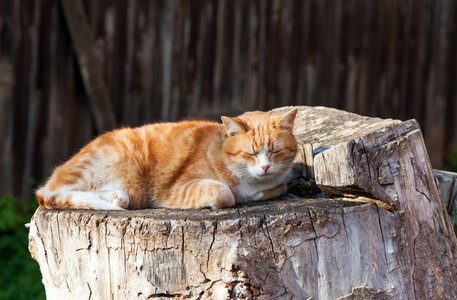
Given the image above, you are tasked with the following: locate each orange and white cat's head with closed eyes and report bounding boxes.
[222,109,298,182]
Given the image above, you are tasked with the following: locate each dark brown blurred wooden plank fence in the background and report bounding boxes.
[0,0,457,202]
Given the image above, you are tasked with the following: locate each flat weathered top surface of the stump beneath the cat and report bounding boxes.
[37,198,371,221]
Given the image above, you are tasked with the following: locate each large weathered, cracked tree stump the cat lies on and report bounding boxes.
[29,107,457,299]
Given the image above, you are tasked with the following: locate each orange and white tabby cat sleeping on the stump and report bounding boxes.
[36,109,297,210]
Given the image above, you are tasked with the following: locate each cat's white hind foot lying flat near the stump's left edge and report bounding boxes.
[35,187,129,210]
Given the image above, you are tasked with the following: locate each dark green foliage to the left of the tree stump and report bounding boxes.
[0,196,45,300]
